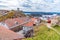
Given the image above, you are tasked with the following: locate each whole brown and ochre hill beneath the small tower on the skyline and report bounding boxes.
[0,10,25,21]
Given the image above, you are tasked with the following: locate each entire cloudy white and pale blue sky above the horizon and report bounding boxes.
[0,0,60,12]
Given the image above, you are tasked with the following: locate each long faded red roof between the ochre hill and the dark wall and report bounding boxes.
[5,18,25,28]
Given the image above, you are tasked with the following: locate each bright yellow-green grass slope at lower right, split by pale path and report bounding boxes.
[24,26,60,40]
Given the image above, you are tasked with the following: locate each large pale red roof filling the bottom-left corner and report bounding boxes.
[0,26,23,40]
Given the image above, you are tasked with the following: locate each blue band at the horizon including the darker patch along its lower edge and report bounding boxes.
[24,12,60,16]
